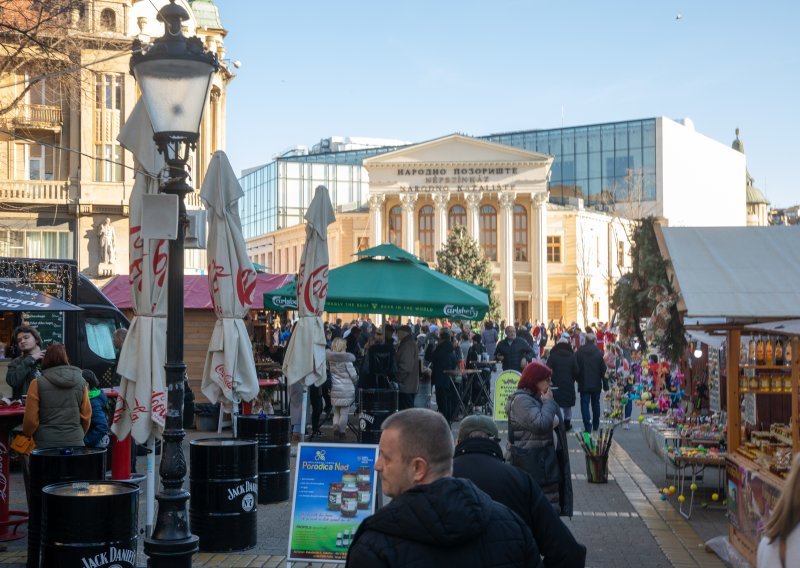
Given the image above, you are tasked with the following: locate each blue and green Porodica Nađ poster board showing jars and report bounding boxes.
[287,443,378,564]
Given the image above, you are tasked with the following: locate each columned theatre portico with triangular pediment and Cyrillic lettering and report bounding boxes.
[364,135,553,321]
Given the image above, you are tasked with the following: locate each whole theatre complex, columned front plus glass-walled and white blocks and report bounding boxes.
[240,117,746,324]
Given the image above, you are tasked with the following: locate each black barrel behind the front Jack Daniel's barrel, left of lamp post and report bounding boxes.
[28,447,106,568]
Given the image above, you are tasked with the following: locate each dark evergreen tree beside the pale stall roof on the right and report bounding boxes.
[611,217,686,362]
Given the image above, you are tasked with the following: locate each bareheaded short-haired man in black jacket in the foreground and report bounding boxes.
[347,408,541,568]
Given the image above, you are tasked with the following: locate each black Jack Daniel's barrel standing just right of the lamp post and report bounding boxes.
[189,438,258,552]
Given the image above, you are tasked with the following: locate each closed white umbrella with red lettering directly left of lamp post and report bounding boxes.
[111,101,169,444]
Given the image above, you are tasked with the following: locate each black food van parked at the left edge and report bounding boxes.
[0,257,130,385]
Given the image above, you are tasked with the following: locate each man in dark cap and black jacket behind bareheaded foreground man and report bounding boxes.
[453,415,586,568]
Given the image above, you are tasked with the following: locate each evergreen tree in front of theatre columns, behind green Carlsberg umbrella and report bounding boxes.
[436,226,500,321]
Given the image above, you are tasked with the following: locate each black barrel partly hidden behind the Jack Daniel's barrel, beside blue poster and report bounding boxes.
[236,415,291,503]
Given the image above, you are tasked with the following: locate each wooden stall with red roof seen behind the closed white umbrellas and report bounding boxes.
[103,274,294,402]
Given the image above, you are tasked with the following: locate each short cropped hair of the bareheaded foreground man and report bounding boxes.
[383,408,455,477]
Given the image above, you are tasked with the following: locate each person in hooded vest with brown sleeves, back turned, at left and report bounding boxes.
[22,344,92,449]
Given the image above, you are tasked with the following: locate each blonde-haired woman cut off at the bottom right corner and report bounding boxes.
[758,454,800,568]
